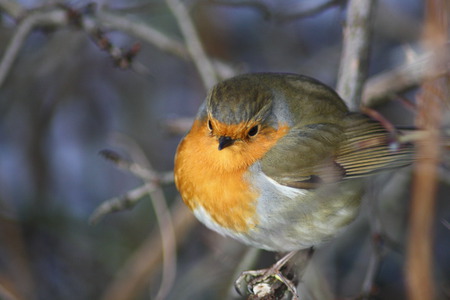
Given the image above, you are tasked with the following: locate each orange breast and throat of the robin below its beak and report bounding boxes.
[175,120,287,232]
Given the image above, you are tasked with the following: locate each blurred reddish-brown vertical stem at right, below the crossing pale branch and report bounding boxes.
[406,81,442,300]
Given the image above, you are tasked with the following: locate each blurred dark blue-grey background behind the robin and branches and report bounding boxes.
[0,0,450,300]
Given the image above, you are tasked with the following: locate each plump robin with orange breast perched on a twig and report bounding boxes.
[175,73,412,296]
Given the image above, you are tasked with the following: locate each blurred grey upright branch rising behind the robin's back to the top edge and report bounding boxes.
[336,0,375,111]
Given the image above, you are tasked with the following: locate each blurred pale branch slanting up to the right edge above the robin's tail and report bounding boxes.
[362,43,450,107]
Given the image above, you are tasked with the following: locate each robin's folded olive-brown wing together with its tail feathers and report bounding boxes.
[262,114,413,188]
